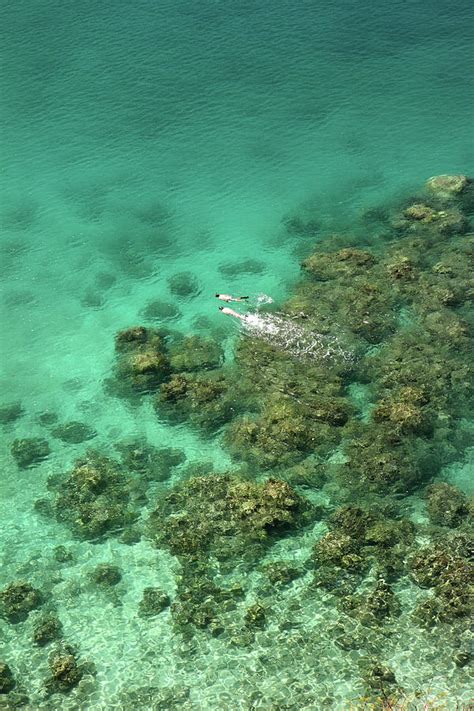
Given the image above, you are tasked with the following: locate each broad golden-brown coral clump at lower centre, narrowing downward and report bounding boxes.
[148,474,312,635]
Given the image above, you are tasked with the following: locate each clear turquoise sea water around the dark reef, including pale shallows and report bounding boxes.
[0,0,474,710]
